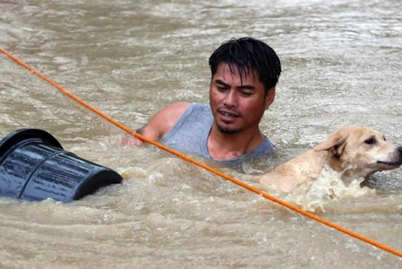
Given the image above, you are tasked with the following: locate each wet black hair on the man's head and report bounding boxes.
[209,37,282,96]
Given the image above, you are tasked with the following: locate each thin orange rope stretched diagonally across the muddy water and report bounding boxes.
[0,47,402,258]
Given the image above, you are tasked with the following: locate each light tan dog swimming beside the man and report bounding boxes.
[259,126,402,192]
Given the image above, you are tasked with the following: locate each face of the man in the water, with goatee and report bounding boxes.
[209,62,275,134]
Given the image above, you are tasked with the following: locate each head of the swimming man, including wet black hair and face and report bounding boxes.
[209,37,281,134]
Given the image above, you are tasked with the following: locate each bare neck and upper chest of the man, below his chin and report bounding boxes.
[207,127,265,160]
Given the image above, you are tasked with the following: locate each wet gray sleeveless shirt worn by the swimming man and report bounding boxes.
[160,103,274,170]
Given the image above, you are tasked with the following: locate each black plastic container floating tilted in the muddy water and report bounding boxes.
[0,129,122,202]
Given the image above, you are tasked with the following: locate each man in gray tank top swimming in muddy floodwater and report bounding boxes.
[125,37,281,170]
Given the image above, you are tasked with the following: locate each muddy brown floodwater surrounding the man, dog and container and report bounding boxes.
[0,0,402,268]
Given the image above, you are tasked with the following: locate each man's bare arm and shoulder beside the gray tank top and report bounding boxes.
[122,102,190,146]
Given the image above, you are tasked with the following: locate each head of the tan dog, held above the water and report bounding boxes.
[314,127,402,177]
